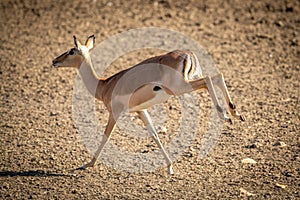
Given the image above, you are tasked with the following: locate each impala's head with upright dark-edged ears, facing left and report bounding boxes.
[52,35,95,68]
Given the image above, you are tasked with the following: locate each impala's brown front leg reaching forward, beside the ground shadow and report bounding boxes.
[77,113,116,169]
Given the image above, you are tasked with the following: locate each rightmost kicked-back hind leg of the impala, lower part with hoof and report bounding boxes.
[212,74,245,121]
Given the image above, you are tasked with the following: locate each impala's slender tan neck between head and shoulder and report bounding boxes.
[79,56,104,100]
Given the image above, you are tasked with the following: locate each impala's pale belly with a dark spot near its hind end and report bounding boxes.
[129,84,170,112]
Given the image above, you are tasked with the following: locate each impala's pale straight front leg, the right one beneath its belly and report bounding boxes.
[137,110,174,174]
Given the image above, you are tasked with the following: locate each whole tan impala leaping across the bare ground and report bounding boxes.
[52,35,245,174]
